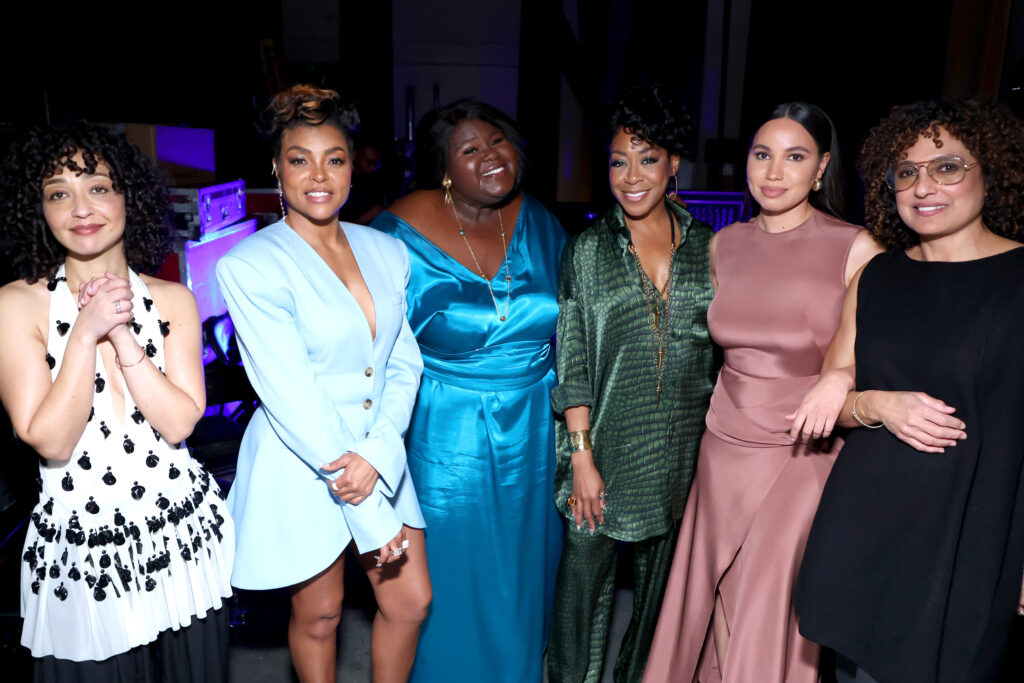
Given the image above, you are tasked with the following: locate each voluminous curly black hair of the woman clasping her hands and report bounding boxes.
[0,122,172,284]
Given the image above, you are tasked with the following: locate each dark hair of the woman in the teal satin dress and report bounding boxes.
[413,99,526,198]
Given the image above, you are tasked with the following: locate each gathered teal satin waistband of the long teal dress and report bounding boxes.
[420,341,555,391]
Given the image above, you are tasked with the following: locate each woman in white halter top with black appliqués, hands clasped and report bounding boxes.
[0,124,234,682]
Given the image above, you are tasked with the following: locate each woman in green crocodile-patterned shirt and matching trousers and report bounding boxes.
[548,87,714,682]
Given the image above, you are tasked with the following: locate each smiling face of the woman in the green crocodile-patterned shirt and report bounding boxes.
[608,128,679,219]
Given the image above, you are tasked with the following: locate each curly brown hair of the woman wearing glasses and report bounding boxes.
[858,98,1024,249]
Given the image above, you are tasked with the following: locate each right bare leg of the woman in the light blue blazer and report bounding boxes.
[359,526,432,683]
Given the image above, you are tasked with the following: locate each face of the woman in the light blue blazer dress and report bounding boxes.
[274,124,352,227]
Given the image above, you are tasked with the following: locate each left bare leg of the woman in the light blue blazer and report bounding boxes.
[288,555,345,683]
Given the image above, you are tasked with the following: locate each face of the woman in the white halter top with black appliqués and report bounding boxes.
[42,155,125,259]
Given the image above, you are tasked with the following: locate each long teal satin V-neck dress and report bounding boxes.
[373,196,565,683]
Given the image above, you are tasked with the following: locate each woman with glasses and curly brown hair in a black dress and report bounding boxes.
[797,100,1024,682]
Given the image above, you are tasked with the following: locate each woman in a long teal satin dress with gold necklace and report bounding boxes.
[373,100,565,683]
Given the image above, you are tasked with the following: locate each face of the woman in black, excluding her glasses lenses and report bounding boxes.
[896,127,985,242]
